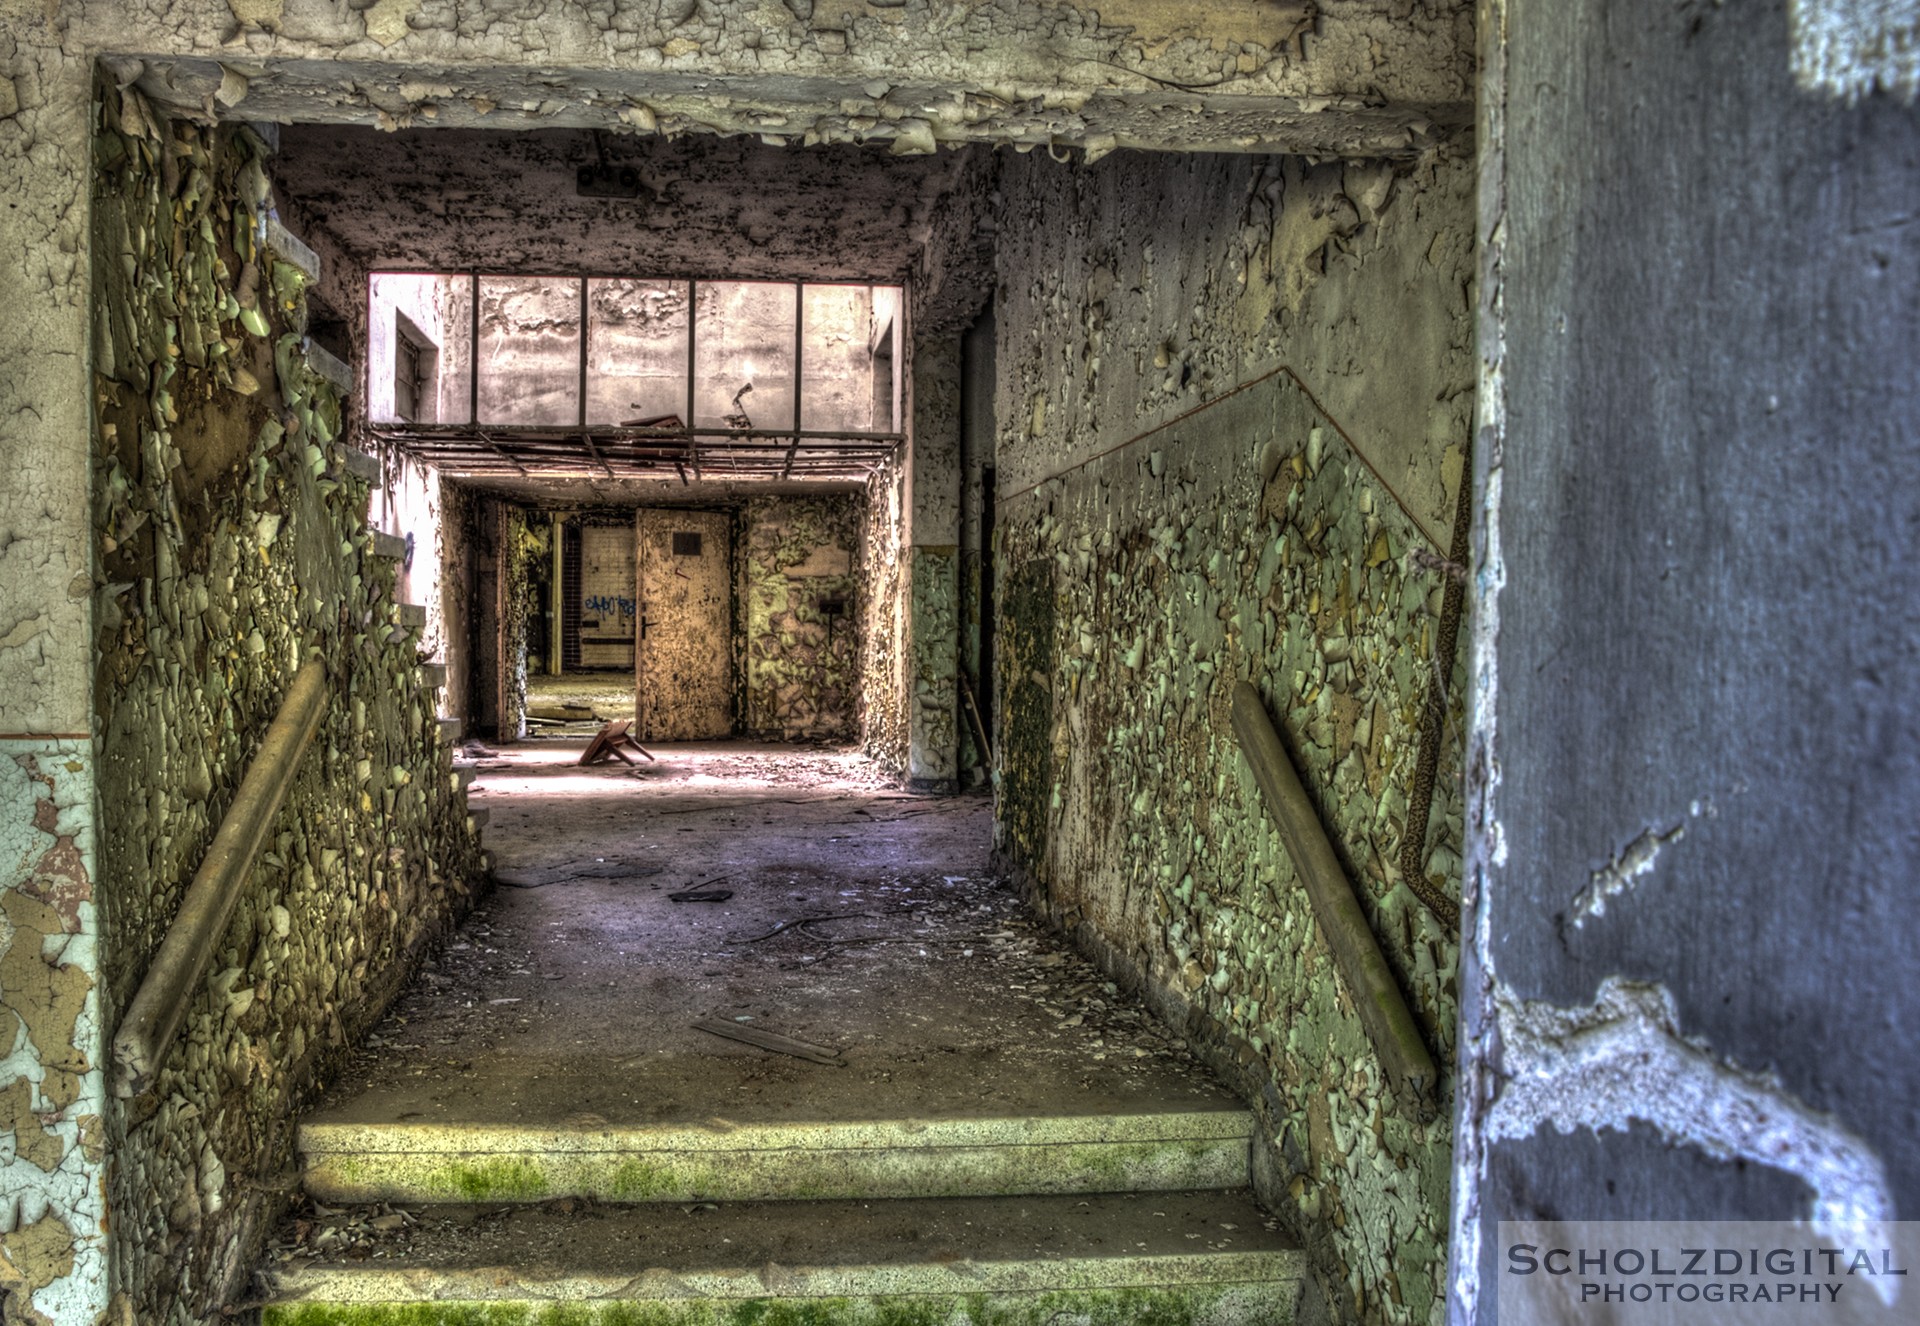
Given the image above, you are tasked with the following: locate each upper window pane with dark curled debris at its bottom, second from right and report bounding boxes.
[693,280,797,428]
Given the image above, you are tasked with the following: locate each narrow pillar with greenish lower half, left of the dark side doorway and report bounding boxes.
[906,336,960,793]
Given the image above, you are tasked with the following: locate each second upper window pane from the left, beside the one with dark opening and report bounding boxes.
[480,276,580,424]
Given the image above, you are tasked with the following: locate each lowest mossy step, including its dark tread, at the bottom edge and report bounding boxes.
[261,1192,1306,1326]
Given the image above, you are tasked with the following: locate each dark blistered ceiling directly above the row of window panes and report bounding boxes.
[275,125,968,280]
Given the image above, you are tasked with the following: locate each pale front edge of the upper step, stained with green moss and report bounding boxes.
[300,1109,1252,1203]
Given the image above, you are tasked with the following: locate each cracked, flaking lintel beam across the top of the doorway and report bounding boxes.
[90,0,1473,155]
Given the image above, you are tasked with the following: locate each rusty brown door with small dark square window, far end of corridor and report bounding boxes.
[634,509,733,741]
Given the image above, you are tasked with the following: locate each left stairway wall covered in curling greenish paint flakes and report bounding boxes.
[87,101,478,1324]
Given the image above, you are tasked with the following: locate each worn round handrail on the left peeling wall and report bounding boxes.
[113,658,326,1098]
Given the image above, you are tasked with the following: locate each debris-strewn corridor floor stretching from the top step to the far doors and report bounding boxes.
[321,741,1236,1126]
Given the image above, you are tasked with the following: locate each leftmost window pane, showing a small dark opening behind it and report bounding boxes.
[367,272,472,424]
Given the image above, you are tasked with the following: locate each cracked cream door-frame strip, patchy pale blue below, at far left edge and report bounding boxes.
[0,23,108,1324]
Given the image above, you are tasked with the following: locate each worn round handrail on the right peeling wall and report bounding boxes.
[1233,681,1440,1119]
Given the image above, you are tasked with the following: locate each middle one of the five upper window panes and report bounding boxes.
[588,280,687,424]
